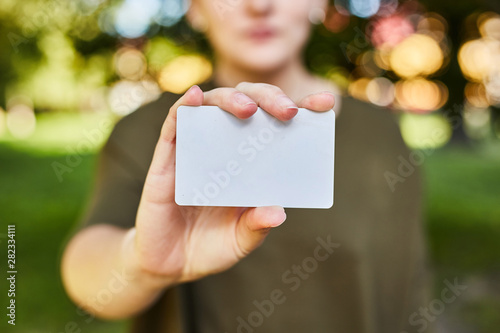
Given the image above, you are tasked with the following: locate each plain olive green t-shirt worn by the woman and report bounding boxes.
[83,84,430,333]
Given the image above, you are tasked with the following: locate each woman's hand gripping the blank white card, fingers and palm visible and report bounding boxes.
[125,82,335,287]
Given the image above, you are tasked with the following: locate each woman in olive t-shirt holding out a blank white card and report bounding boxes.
[62,0,427,332]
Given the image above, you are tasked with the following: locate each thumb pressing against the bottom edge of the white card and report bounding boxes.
[236,206,286,258]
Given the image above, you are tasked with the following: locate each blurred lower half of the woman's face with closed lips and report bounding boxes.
[188,0,326,72]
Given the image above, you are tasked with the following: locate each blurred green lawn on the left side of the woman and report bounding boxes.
[0,114,126,333]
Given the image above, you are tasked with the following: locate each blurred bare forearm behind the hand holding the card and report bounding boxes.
[61,224,173,319]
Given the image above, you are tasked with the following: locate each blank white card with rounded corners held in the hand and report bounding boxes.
[175,106,335,208]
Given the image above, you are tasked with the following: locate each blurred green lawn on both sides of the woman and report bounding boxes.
[0,114,500,333]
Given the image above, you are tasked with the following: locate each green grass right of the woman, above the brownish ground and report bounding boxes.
[424,145,500,273]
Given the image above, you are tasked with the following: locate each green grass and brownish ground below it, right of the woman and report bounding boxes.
[423,143,500,333]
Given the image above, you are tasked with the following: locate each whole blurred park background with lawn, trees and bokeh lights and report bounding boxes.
[0,0,500,333]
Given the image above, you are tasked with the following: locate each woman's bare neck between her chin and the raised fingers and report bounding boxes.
[214,59,313,100]
